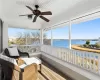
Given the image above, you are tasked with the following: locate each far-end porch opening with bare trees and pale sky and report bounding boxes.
[8,28,40,46]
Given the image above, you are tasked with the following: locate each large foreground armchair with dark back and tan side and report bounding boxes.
[0,54,38,80]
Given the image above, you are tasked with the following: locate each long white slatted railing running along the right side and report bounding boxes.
[41,45,100,75]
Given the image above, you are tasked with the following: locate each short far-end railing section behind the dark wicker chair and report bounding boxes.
[9,45,40,54]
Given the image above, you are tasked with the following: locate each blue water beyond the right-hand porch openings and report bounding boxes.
[53,40,97,48]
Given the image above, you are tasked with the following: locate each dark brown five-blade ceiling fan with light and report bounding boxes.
[19,5,52,22]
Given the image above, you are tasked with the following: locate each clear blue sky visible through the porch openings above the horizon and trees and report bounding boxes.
[8,18,100,39]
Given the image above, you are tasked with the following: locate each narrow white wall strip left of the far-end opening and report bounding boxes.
[3,23,8,50]
